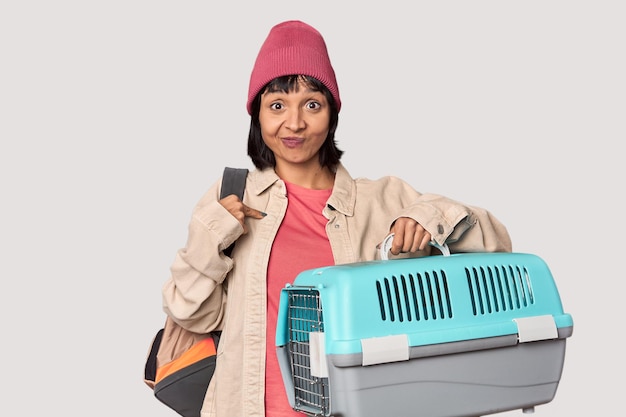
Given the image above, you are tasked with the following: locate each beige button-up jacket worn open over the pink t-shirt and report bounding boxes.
[163,165,511,417]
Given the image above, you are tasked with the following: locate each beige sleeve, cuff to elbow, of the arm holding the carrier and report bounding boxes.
[396,186,512,252]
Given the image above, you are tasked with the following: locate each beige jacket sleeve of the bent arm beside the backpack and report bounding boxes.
[162,180,243,333]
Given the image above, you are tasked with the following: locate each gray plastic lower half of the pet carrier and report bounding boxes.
[278,328,572,417]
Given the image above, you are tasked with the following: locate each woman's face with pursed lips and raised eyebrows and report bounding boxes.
[259,77,330,168]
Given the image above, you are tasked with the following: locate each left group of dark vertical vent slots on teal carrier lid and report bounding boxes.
[376,271,452,322]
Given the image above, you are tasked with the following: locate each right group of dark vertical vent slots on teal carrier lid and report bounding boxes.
[465,265,535,316]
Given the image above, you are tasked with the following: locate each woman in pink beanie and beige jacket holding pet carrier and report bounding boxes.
[163,21,511,417]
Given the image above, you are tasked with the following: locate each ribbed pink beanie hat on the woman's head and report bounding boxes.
[246,20,341,114]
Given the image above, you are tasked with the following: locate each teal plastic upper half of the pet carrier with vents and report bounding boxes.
[276,253,573,354]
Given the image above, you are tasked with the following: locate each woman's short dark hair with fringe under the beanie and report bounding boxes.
[248,75,343,170]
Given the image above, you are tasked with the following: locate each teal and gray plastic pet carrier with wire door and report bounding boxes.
[276,240,573,417]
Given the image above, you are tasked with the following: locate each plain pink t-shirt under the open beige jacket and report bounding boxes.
[265,182,335,417]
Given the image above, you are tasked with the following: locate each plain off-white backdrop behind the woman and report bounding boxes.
[0,0,626,417]
